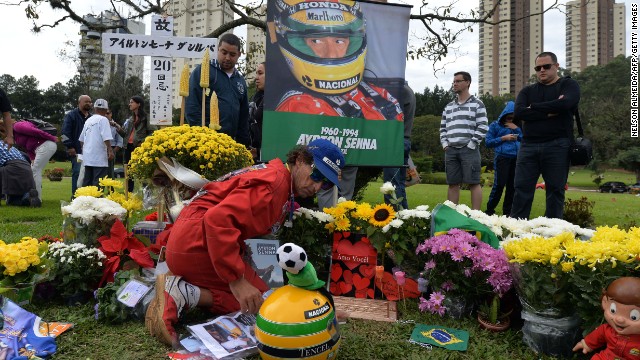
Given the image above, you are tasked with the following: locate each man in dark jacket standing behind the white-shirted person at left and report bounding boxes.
[62,95,93,199]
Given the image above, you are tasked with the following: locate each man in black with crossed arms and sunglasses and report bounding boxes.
[511,51,580,219]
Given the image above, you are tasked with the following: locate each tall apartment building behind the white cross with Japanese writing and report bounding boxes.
[78,11,145,90]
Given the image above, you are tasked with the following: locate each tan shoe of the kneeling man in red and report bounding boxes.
[144,274,196,348]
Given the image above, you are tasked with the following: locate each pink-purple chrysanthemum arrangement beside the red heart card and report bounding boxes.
[416,229,512,315]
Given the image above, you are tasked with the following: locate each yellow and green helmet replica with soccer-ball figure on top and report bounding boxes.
[255,243,340,360]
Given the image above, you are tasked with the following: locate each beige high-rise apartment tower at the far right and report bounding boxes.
[566,0,626,71]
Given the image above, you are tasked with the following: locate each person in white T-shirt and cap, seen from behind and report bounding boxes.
[79,99,113,186]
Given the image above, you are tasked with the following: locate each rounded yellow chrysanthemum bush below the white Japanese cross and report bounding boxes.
[129,125,253,180]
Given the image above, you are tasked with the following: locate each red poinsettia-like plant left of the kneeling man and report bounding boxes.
[98,219,154,287]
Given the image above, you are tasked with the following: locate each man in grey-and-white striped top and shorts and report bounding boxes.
[440,71,489,210]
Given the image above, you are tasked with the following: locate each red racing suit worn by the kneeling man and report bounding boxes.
[166,159,291,312]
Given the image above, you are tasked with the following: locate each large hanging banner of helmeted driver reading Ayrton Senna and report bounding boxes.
[262,0,411,166]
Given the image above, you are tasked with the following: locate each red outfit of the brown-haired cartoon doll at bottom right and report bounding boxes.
[584,324,640,360]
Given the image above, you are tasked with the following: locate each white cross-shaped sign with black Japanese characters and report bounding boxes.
[102,15,218,125]
